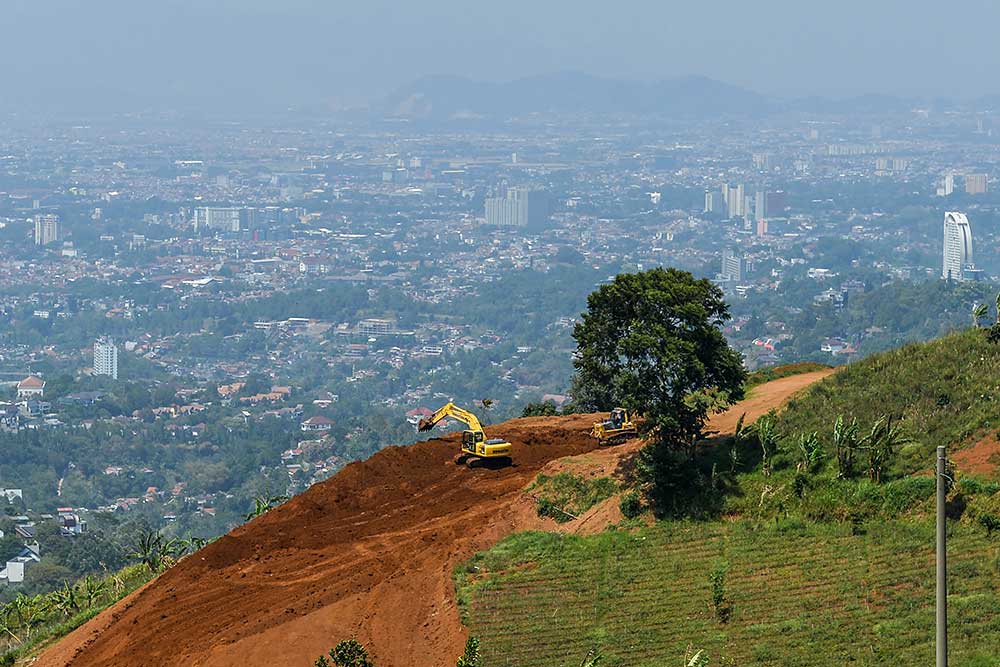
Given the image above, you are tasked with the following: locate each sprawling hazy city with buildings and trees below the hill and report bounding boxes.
[0,103,1000,599]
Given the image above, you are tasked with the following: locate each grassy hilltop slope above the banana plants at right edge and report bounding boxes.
[778,329,1000,474]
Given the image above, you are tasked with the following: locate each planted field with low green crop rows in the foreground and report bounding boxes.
[456,522,1000,667]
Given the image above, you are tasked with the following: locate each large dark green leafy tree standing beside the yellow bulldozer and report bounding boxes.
[572,268,746,507]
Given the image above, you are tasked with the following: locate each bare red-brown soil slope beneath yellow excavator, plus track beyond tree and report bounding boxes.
[41,371,828,667]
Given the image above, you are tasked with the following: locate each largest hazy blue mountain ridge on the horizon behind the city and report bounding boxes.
[380,72,774,119]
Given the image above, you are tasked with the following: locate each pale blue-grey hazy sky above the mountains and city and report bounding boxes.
[0,0,1000,110]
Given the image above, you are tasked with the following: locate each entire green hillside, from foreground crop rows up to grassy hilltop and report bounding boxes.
[456,330,1000,667]
